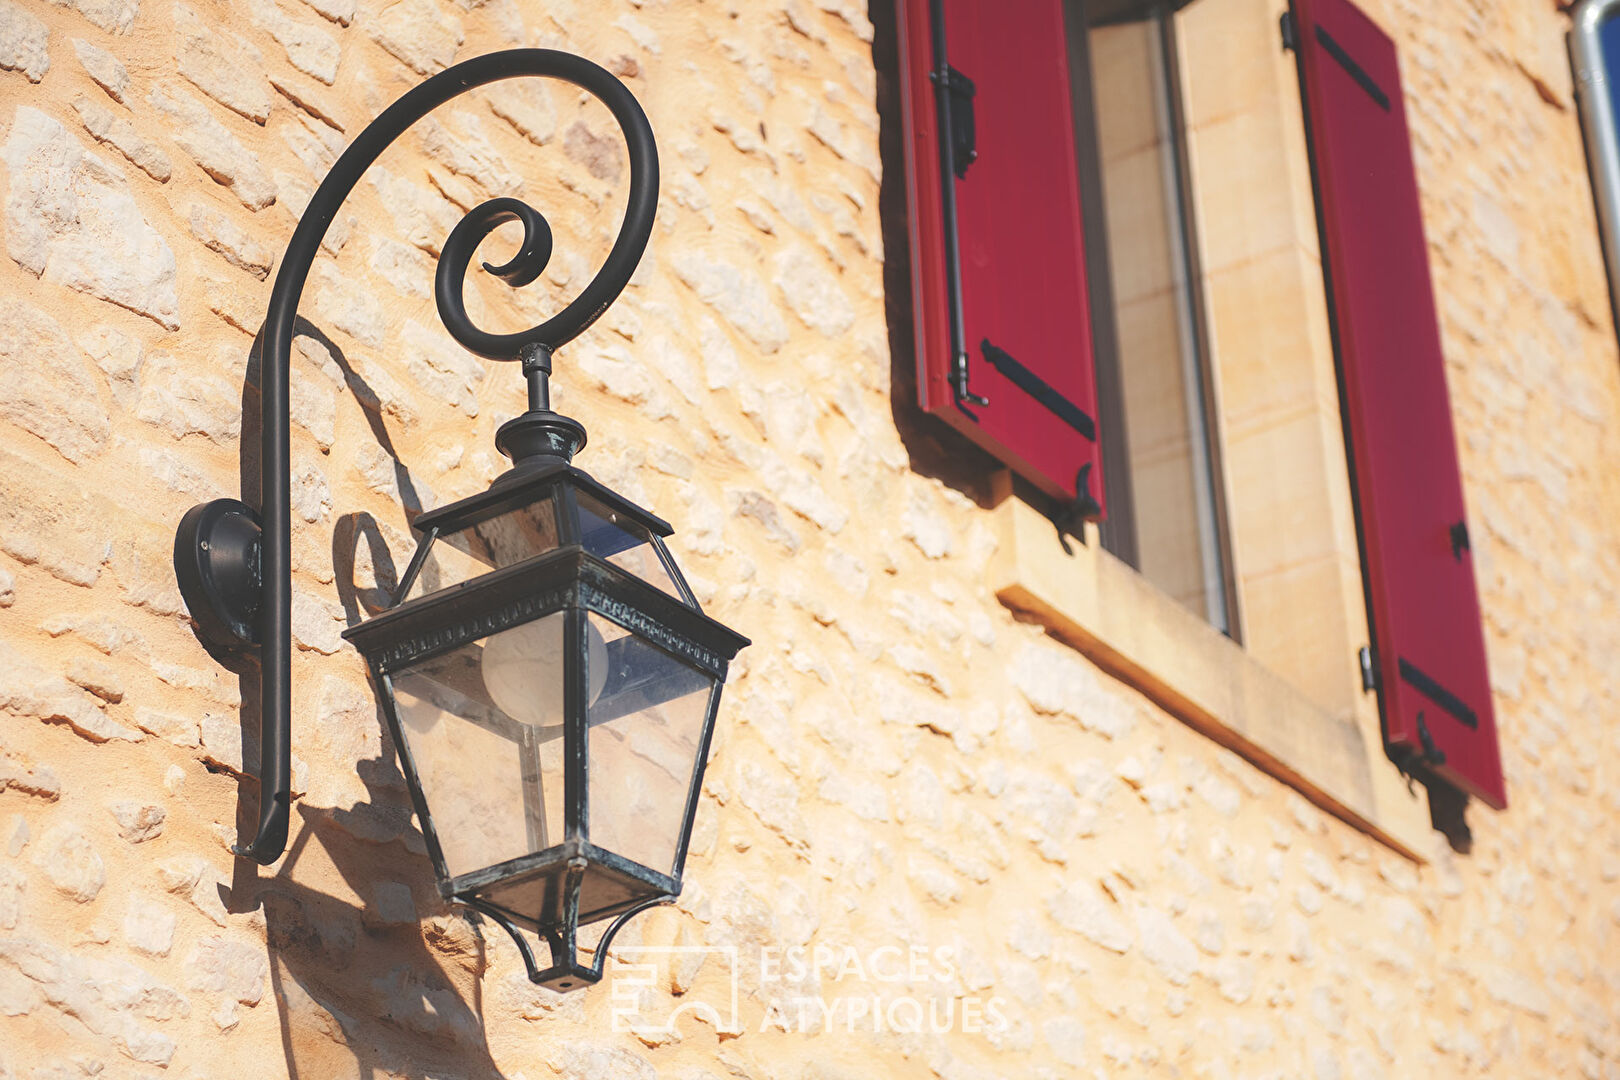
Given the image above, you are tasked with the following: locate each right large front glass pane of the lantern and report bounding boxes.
[586,612,714,874]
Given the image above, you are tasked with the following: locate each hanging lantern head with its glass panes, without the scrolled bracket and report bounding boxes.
[345,430,747,989]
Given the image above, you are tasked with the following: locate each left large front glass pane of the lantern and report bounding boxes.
[394,612,567,876]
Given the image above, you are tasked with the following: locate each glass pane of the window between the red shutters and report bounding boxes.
[1089,5,1228,630]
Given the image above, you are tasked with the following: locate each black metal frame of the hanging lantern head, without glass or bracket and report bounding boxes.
[343,458,747,989]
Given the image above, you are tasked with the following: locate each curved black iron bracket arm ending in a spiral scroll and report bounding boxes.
[235,49,658,863]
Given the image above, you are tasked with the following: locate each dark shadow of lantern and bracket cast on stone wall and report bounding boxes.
[218,348,505,1080]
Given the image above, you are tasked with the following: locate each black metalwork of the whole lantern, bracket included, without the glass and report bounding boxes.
[175,49,747,989]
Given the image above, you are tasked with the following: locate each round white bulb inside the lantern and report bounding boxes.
[483,612,608,727]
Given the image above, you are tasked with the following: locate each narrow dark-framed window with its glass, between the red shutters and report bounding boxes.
[1068,0,1241,638]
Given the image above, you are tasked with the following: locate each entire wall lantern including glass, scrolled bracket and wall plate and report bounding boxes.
[175,49,748,989]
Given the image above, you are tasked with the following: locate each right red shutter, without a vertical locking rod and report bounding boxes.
[1293,0,1507,810]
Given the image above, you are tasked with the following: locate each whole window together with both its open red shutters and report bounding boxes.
[897,0,1505,835]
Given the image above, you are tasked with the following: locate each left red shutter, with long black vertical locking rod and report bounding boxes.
[899,0,1102,507]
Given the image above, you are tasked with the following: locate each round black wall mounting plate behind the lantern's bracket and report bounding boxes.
[175,499,264,653]
